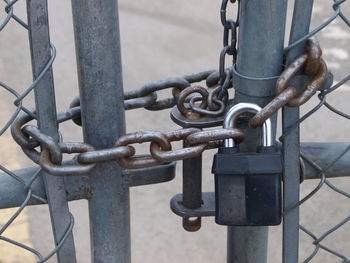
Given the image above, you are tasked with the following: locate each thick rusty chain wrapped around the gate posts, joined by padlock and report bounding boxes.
[11,35,327,175]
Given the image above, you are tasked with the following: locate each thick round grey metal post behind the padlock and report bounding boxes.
[227,0,287,263]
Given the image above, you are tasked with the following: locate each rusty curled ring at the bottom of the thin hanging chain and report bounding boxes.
[177,86,209,119]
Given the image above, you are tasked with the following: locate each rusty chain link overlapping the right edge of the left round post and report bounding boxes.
[115,131,171,169]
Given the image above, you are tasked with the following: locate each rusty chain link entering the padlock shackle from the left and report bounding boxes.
[186,128,244,145]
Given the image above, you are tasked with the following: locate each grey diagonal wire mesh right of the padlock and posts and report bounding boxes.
[280,0,350,263]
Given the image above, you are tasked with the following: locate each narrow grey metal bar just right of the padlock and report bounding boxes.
[282,0,313,263]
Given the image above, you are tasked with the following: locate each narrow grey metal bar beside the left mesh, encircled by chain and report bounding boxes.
[27,0,76,263]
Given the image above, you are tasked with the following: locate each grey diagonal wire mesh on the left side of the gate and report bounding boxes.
[0,0,74,263]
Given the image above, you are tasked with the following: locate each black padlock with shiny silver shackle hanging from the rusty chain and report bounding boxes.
[212,103,283,226]
